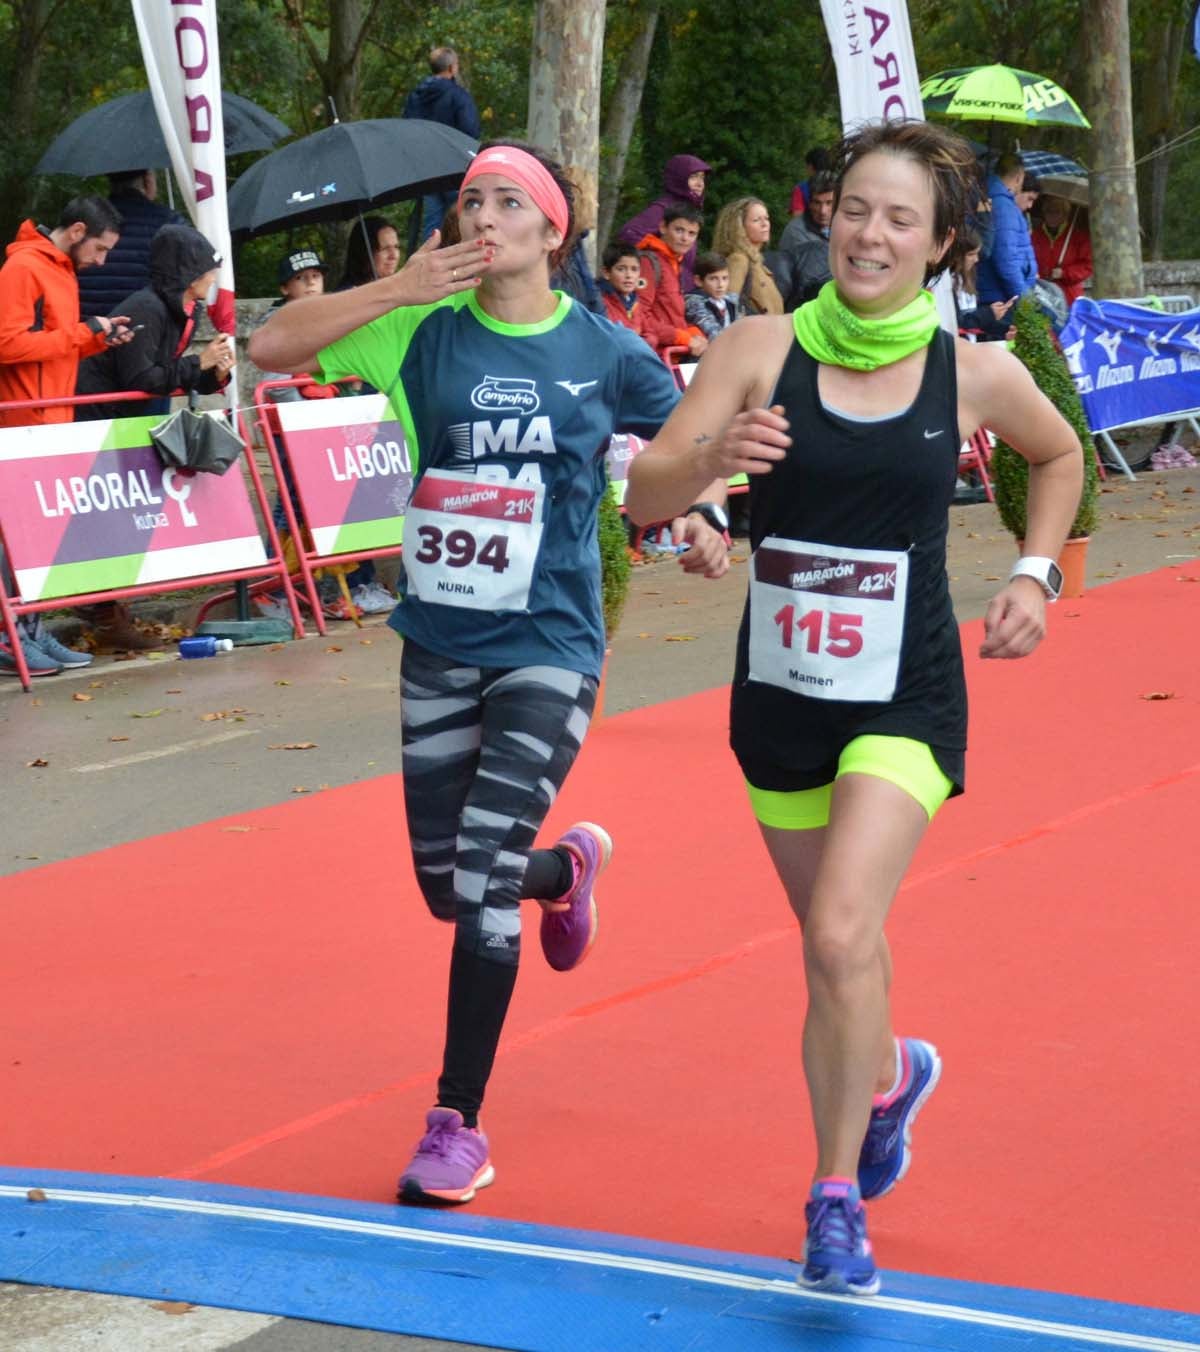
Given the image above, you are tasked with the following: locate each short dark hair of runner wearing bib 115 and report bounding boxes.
[832,120,978,281]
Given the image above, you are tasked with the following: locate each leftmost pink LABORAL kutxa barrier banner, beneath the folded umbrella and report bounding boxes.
[0,418,266,600]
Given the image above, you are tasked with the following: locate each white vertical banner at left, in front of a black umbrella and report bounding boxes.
[131,0,234,334]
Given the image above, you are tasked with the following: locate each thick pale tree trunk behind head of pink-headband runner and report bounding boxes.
[528,0,604,266]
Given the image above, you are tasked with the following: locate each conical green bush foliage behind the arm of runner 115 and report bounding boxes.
[988,295,1100,539]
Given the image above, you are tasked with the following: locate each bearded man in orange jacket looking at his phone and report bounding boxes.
[0,196,134,427]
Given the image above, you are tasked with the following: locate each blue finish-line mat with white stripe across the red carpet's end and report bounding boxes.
[0,1168,1200,1352]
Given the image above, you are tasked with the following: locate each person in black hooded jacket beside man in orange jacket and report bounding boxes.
[76,226,236,422]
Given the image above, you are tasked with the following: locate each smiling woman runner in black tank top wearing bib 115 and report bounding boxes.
[626,122,1082,1295]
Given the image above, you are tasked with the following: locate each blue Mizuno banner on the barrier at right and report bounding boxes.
[1058,299,1200,431]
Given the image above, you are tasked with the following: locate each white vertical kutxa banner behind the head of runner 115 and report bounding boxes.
[820,0,958,333]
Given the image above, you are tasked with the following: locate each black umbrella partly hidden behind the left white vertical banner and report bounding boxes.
[34,89,292,178]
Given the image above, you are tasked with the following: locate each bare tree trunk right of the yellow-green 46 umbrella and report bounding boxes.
[1084,0,1142,299]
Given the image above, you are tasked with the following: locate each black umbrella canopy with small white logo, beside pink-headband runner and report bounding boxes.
[230,118,478,239]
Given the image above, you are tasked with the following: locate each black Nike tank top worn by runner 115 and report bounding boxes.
[730,330,966,792]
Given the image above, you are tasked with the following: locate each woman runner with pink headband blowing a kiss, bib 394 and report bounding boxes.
[250,143,728,1202]
